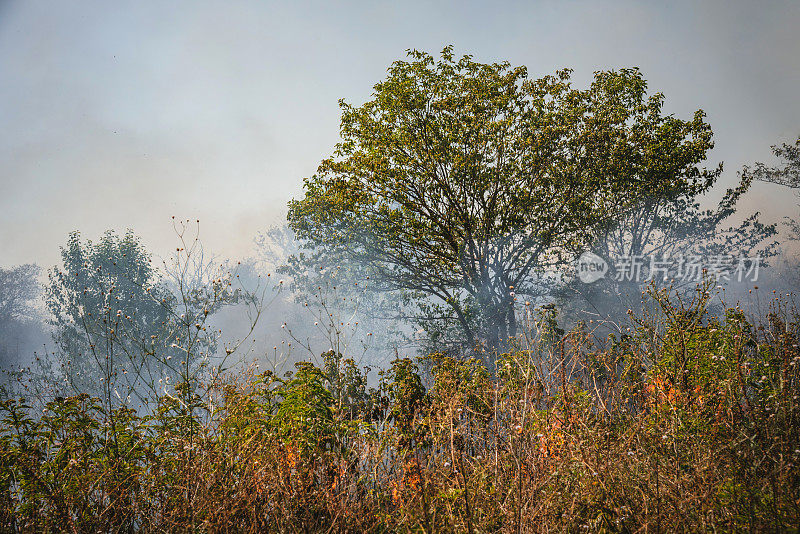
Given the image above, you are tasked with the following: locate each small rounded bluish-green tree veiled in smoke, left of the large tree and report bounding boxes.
[45,232,180,400]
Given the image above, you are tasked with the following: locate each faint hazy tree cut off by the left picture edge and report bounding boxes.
[0,264,40,369]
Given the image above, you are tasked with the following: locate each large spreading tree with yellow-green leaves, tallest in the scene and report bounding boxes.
[289,48,713,356]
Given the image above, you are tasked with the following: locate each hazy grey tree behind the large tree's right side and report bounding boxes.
[555,167,776,327]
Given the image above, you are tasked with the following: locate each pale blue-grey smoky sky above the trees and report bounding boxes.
[0,0,800,267]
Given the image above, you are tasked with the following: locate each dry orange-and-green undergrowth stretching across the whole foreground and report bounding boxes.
[0,293,800,532]
